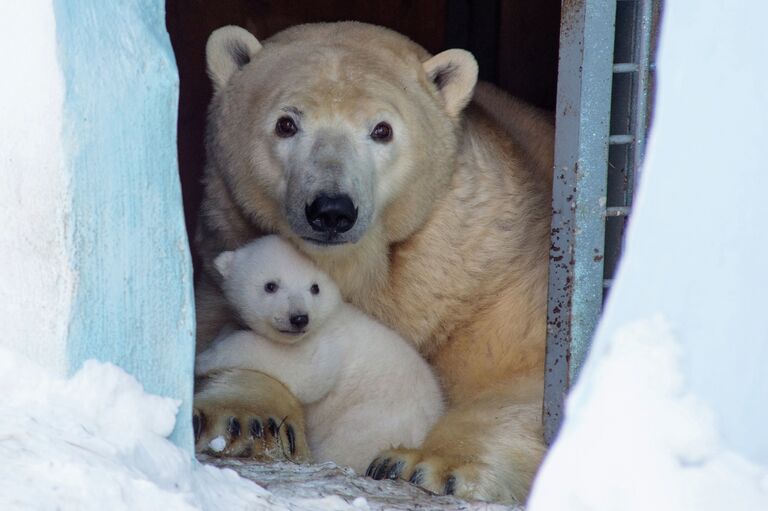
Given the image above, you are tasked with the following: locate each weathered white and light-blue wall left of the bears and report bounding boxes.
[0,0,194,449]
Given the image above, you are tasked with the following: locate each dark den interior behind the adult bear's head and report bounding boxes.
[166,0,560,270]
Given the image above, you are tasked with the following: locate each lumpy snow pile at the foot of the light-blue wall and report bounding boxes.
[0,347,368,511]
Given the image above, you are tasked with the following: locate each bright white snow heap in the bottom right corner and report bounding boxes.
[528,316,768,511]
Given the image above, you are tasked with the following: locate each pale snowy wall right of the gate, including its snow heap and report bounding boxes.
[528,0,768,511]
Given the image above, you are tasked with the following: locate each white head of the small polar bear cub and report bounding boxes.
[214,236,341,344]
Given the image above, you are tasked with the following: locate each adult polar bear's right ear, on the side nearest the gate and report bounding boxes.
[424,49,477,117]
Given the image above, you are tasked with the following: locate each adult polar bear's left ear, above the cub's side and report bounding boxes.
[205,25,261,92]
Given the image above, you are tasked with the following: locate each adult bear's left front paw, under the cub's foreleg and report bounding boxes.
[192,370,311,462]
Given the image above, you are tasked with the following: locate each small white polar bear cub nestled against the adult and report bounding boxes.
[195,236,443,473]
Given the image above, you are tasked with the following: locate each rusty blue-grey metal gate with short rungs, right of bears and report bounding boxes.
[544,0,660,443]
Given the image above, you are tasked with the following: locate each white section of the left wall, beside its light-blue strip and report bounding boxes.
[0,0,74,374]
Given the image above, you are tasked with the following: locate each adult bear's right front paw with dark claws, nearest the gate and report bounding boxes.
[365,449,483,500]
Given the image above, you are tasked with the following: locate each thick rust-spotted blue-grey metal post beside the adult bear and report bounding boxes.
[544,0,616,442]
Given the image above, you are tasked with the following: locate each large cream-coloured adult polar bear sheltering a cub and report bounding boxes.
[195,22,552,502]
